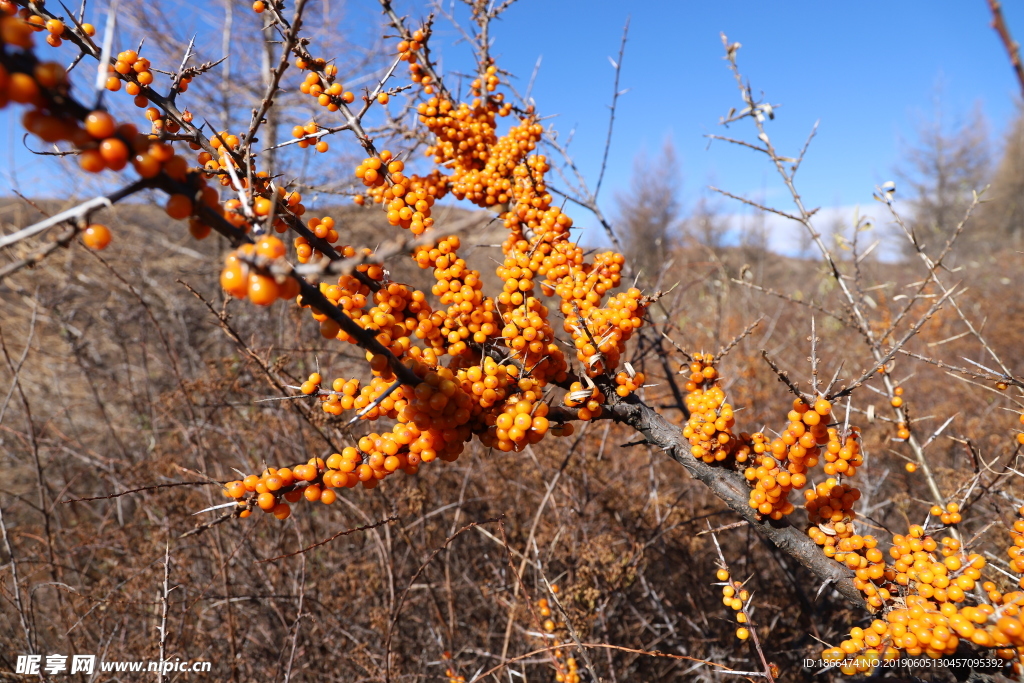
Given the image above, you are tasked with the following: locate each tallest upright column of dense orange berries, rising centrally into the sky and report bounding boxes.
[395,32,646,395]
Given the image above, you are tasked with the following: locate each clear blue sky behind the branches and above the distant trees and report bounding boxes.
[0,0,1024,250]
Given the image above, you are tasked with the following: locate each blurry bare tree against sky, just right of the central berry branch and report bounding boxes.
[615,138,682,278]
